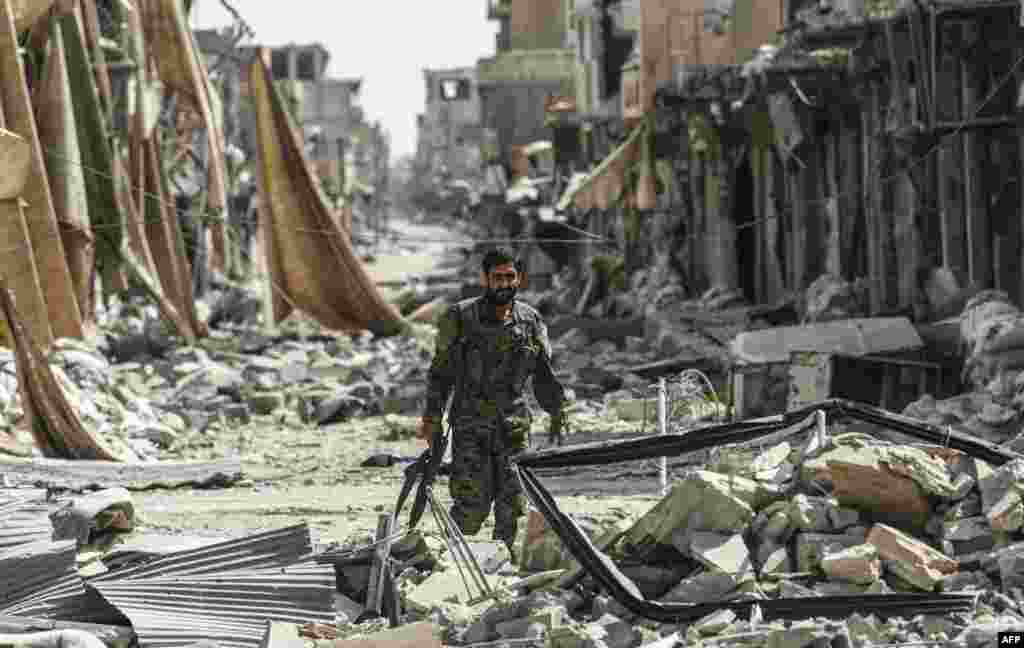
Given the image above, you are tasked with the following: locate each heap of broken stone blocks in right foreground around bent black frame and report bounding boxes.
[378,427,1024,648]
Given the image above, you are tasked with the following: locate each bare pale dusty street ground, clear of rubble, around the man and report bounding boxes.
[135,214,657,542]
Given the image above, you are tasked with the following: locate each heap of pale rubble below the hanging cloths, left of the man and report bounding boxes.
[0,298,432,461]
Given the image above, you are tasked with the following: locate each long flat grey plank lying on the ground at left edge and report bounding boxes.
[0,457,243,490]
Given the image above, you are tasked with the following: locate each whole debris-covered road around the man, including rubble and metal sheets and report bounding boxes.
[6,216,1024,648]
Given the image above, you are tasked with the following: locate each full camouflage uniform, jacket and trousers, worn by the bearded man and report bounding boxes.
[425,298,565,544]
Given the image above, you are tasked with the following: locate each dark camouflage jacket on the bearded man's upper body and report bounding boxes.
[424,297,565,420]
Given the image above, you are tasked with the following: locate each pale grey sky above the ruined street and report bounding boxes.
[191,0,497,162]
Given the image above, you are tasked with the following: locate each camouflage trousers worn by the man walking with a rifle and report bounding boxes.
[450,416,529,543]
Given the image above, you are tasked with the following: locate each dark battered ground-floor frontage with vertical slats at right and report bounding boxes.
[638,4,1022,316]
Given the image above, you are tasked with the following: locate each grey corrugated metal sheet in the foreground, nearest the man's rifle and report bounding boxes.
[90,560,336,648]
